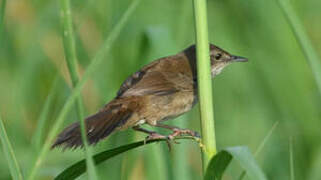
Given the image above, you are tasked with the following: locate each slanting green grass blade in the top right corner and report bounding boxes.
[278,0,321,94]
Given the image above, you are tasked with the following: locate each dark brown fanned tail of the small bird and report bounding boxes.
[51,101,132,148]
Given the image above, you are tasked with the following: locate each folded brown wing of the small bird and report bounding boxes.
[117,57,193,97]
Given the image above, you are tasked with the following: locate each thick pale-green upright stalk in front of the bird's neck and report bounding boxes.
[193,0,216,172]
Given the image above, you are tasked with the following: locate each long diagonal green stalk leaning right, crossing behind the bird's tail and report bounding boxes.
[29,0,141,179]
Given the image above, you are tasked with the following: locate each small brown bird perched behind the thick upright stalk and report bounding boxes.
[52,44,247,148]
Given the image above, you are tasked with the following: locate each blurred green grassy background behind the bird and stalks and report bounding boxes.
[0,0,321,180]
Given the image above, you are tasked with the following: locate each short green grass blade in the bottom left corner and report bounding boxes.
[0,116,23,180]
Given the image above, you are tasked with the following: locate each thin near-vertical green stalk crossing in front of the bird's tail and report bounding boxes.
[60,0,97,180]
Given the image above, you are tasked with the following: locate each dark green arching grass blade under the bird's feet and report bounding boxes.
[55,137,194,180]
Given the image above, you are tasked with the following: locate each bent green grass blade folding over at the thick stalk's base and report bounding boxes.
[205,146,267,180]
